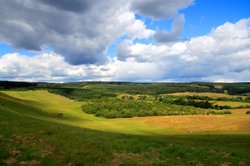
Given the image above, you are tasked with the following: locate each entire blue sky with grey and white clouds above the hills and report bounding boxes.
[0,0,250,82]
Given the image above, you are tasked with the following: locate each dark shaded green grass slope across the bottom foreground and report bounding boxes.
[0,91,250,166]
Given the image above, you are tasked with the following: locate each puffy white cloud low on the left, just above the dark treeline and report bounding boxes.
[0,53,86,82]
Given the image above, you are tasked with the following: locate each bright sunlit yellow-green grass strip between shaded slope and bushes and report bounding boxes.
[0,90,167,135]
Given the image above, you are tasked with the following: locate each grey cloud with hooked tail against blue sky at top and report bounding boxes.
[131,0,193,43]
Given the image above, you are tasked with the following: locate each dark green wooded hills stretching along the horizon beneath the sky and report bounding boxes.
[0,81,250,95]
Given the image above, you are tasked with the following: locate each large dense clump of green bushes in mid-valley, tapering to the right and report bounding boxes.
[82,98,231,118]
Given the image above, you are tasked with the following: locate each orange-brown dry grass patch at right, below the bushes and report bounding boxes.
[127,113,250,134]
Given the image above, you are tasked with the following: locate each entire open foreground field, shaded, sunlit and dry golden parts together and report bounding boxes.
[0,90,250,165]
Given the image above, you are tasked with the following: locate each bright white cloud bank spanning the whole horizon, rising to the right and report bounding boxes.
[0,18,250,82]
